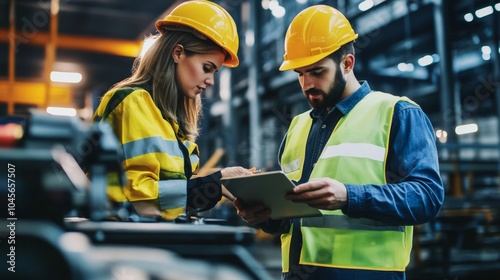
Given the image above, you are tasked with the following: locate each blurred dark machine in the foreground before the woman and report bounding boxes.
[0,112,270,280]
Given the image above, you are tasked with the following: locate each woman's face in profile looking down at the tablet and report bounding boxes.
[172,45,225,99]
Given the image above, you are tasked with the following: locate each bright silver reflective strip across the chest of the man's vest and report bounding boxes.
[321,143,385,161]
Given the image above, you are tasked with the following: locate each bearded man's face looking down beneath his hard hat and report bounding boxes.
[294,58,346,110]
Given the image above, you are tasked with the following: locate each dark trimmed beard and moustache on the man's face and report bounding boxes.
[305,65,347,110]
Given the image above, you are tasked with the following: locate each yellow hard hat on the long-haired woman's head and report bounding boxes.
[156,0,240,67]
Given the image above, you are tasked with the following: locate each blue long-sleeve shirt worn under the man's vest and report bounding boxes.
[260,82,444,279]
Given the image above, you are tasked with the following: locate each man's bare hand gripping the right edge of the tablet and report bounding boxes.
[285,178,347,210]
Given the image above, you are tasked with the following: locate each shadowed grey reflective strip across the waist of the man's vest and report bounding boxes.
[302,215,404,232]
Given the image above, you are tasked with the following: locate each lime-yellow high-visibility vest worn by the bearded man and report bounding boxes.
[281,92,413,272]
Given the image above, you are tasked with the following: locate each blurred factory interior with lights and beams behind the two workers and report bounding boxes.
[0,0,500,279]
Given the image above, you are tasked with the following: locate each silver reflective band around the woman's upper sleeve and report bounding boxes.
[123,136,184,159]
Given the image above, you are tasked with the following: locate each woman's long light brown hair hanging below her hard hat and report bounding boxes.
[113,28,223,141]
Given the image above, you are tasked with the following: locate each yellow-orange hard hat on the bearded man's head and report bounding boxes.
[279,5,358,71]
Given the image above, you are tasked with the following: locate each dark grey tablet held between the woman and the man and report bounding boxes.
[221,171,323,220]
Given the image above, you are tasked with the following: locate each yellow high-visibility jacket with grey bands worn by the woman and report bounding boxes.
[93,88,199,220]
